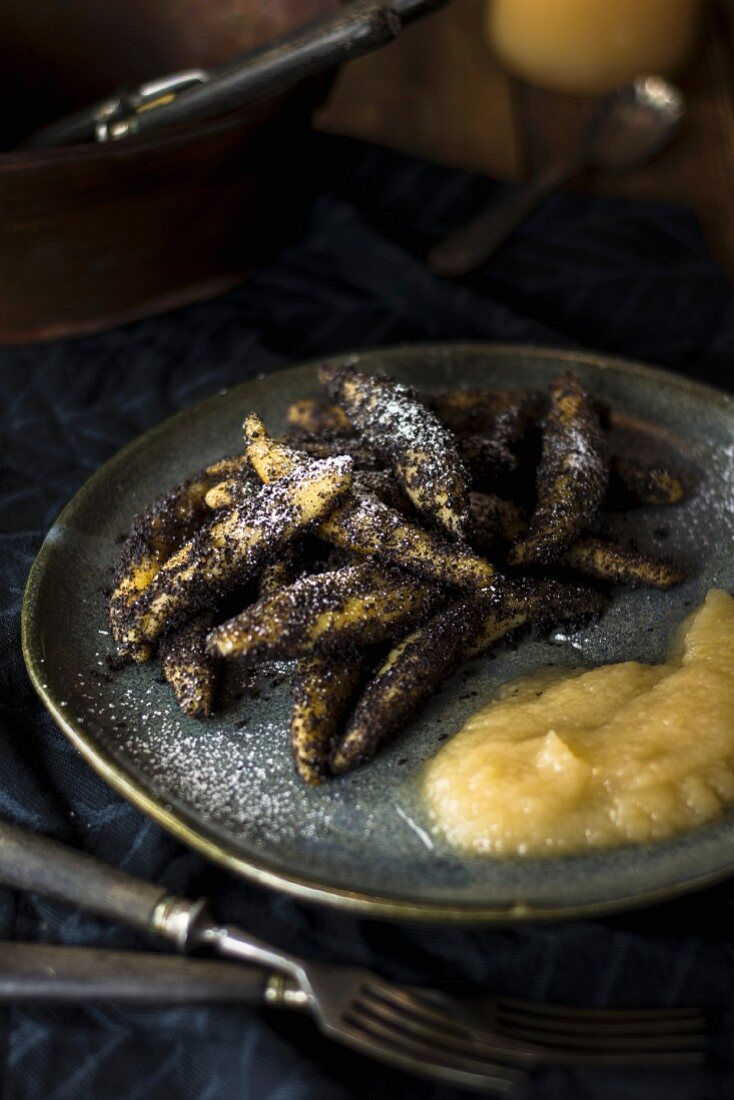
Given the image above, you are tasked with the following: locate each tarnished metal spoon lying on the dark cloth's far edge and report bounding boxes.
[427,76,684,276]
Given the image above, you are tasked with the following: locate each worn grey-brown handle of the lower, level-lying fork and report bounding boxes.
[0,943,267,1004]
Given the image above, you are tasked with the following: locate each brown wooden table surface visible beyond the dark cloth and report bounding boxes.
[317,0,734,277]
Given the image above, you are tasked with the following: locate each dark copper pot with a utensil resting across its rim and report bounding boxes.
[0,0,338,343]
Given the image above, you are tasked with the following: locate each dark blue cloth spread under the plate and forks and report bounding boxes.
[0,139,734,1100]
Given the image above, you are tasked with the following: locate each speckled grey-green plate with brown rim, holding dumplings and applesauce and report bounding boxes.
[23,344,734,921]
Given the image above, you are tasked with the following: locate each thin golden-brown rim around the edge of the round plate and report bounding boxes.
[21,340,734,924]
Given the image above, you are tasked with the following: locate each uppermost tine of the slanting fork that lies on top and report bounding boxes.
[358,986,538,1066]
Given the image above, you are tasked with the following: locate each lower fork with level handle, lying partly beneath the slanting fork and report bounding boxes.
[0,943,706,1068]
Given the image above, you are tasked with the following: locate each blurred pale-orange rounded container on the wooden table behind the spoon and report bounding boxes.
[486,0,701,95]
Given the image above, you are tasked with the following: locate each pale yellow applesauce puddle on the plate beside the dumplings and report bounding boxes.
[423,589,734,856]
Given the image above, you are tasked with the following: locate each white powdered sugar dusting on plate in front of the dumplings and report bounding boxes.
[69,657,413,855]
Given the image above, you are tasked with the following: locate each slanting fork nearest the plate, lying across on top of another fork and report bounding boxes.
[0,822,530,1097]
